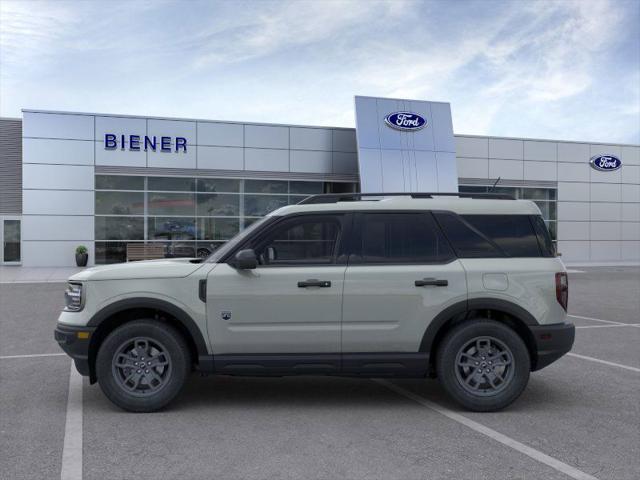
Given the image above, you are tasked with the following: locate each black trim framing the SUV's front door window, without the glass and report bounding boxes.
[219,210,353,268]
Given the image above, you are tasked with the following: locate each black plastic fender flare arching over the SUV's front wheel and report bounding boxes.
[87,297,209,356]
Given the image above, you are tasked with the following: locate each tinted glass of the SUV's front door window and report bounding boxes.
[256,216,340,265]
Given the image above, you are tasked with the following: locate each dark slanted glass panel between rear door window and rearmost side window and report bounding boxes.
[434,213,504,258]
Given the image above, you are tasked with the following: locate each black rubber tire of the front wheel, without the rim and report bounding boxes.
[96,319,190,412]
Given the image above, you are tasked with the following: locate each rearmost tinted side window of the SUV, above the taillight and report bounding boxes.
[462,215,540,257]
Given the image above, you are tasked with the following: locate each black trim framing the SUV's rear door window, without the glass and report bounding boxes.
[347,209,458,267]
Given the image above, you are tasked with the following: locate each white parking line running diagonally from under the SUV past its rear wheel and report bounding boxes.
[374,379,597,480]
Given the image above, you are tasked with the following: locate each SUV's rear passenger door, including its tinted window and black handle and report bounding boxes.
[342,212,467,354]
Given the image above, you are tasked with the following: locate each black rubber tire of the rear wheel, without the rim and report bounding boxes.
[436,319,531,412]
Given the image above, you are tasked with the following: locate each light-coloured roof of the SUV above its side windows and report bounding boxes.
[269,194,540,216]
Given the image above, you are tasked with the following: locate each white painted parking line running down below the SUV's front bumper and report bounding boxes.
[60,361,82,480]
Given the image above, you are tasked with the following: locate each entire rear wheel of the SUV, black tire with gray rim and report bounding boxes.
[436,319,531,412]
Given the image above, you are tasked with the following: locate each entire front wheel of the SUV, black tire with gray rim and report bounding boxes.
[96,319,191,412]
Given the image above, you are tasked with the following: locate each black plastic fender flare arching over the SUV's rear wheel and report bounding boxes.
[420,298,539,353]
